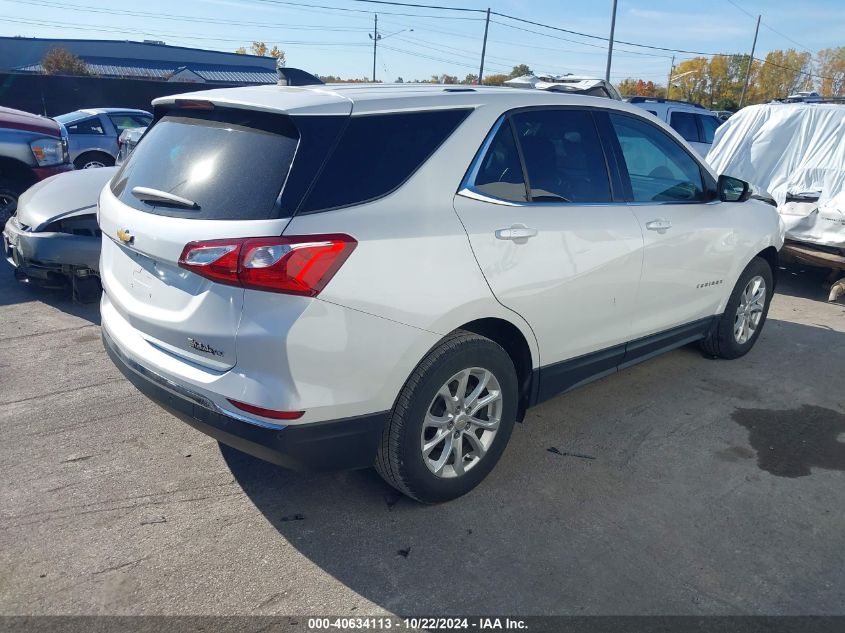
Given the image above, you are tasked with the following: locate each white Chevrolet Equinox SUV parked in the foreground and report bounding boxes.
[99,85,783,502]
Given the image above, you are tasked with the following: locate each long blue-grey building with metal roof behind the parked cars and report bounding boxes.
[0,37,276,84]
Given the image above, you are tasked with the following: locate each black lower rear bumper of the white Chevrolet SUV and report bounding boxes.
[103,330,389,471]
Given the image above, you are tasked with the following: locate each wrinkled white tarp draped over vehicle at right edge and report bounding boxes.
[707,103,845,248]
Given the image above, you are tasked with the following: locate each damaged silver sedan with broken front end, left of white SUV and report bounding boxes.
[3,167,118,301]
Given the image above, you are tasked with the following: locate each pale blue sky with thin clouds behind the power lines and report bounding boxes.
[0,0,845,84]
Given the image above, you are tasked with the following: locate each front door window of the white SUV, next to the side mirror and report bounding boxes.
[610,114,705,202]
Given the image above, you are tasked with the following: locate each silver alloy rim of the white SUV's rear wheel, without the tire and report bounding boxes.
[420,367,503,479]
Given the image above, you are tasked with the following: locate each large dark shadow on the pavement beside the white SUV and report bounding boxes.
[220,319,845,615]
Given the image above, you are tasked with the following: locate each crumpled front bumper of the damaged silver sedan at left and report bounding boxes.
[3,217,101,279]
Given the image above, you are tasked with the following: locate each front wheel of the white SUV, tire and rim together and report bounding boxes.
[701,257,774,360]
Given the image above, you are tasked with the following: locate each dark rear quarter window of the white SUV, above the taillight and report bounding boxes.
[301,110,469,213]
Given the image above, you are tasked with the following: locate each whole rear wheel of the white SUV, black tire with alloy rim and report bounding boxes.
[376,330,519,503]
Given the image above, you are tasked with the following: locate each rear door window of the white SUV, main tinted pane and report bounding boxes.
[512,110,611,203]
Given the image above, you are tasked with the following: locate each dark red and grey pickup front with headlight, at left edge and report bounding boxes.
[0,107,73,229]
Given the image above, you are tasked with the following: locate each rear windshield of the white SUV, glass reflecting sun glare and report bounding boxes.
[111,108,299,220]
